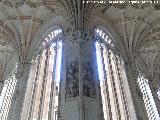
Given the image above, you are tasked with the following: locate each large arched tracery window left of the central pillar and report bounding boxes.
[28,26,63,120]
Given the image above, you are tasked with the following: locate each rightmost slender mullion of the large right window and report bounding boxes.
[115,56,129,120]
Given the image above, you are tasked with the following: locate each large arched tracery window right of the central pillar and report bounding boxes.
[95,27,133,120]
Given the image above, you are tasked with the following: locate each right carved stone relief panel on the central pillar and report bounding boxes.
[82,62,96,97]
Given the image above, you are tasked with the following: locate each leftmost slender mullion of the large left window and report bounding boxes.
[28,56,42,120]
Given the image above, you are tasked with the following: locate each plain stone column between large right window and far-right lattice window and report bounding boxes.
[125,64,149,120]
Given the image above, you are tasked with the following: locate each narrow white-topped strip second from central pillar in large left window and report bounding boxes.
[48,43,57,120]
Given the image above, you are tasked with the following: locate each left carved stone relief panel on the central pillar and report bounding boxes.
[65,59,79,99]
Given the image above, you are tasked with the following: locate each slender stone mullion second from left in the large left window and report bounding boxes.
[38,48,49,120]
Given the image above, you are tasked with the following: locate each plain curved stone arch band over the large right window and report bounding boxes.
[87,11,128,63]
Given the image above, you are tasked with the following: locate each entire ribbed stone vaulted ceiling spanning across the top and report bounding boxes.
[0,0,160,91]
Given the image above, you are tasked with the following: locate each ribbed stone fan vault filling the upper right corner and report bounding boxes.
[96,2,160,89]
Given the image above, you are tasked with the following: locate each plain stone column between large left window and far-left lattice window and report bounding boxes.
[7,62,30,120]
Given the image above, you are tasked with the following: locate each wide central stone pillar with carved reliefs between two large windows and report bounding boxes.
[58,31,103,120]
